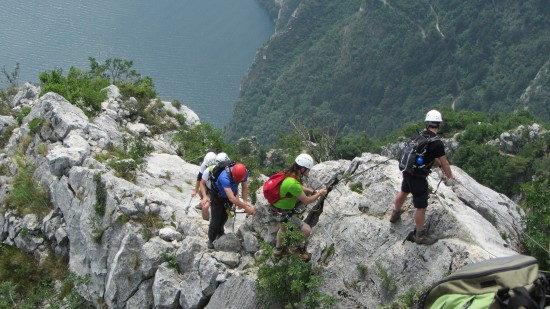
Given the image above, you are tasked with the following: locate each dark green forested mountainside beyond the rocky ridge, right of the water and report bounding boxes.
[225,0,550,143]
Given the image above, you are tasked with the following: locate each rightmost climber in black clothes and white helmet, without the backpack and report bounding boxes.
[390,110,456,245]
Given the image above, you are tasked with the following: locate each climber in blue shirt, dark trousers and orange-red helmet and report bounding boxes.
[208,163,256,249]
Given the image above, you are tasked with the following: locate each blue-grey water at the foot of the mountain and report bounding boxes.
[0,0,274,128]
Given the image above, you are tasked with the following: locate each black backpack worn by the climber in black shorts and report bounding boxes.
[399,132,439,176]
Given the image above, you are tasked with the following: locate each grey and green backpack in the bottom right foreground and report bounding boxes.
[416,255,550,309]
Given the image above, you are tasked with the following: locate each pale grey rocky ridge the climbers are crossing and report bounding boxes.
[0,87,532,308]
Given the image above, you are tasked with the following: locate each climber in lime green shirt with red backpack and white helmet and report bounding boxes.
[263,153,327,261]
